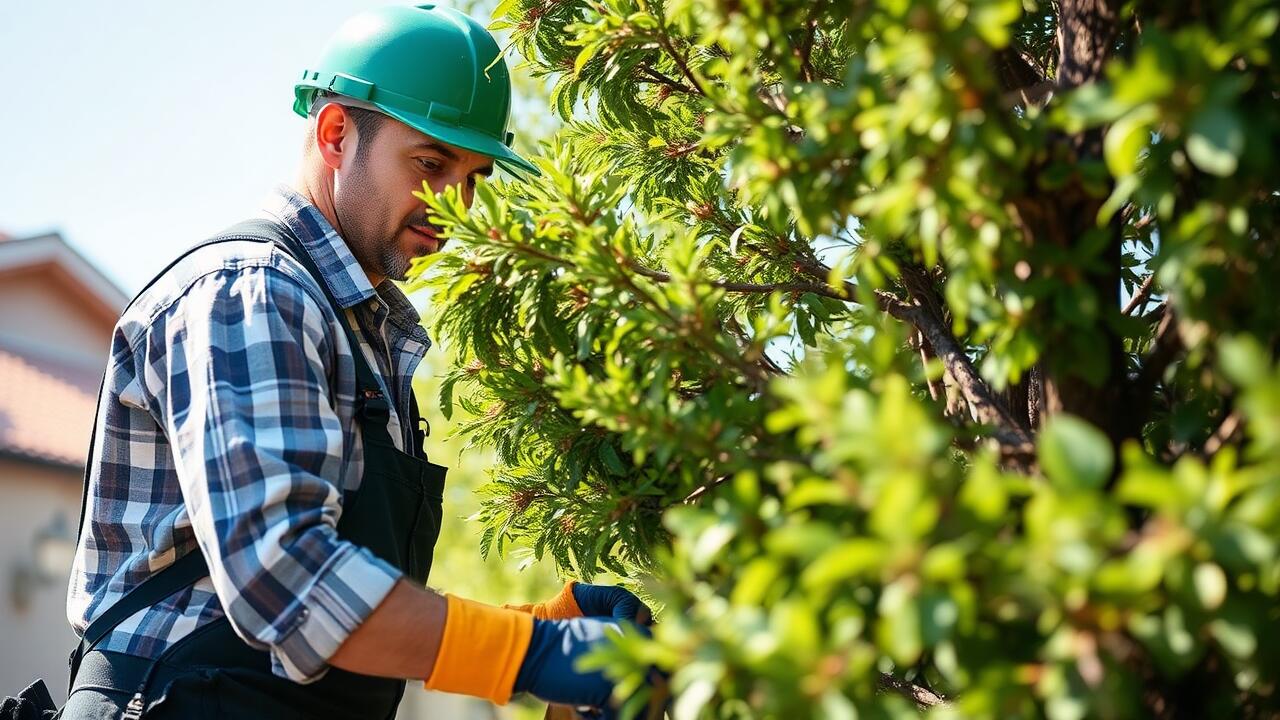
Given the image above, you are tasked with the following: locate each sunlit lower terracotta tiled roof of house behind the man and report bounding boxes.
[0,347,97,465]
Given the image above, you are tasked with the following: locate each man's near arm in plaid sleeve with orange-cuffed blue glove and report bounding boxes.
[153,268,645,706]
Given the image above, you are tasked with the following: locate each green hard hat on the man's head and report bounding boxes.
[293,4,539,174]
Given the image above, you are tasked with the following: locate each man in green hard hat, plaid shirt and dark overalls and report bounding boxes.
[63,5,646,720]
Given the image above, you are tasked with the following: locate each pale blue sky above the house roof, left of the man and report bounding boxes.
[0,0,499,293]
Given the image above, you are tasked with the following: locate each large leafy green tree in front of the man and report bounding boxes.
[409,0,1280,719]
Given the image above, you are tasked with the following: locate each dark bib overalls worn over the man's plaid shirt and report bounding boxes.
[60,220,445,720]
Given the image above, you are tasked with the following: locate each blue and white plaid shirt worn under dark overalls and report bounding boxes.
[67,187,430,683]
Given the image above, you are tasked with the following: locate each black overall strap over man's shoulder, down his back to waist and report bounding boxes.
[68,219,389,692]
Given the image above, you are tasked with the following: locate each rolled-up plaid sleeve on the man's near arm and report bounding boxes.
[143,266,401,683]
